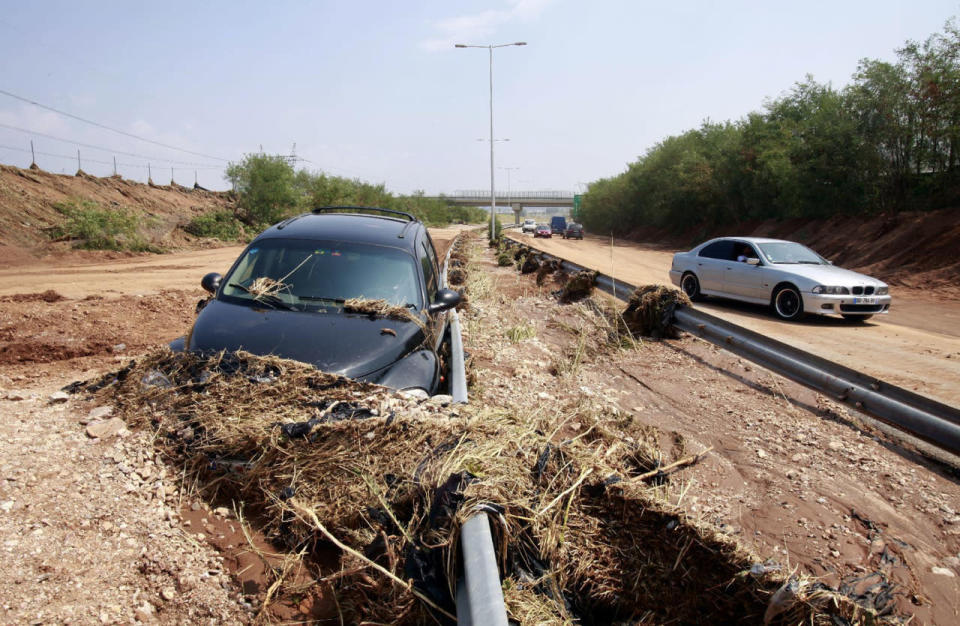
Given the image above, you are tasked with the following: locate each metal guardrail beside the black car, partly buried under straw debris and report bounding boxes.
[440,235,507,626]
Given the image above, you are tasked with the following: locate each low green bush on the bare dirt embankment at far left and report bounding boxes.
[50,199,160,252]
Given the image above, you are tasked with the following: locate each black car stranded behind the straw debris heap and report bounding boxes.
[171,207,460,395]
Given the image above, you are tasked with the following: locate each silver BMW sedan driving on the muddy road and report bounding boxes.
[670,237,890,322]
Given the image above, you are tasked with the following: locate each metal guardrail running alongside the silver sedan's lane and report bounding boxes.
[498,232,960,455]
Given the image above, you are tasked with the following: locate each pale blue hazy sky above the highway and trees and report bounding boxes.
[0,0,960,193]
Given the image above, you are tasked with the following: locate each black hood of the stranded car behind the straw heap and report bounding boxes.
[186,300,424,378]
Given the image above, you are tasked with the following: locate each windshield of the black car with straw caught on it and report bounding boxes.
[221,239,423,311]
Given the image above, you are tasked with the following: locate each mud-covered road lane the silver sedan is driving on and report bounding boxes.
[502,233,960,406]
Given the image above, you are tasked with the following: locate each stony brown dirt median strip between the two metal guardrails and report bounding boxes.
[465,238,960,624]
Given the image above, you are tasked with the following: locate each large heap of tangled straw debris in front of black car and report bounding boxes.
[60,338,896,625]
